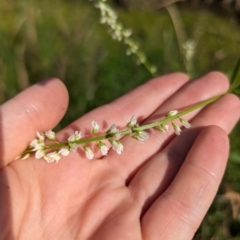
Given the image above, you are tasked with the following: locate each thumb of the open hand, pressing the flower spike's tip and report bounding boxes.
[0,79,68,167]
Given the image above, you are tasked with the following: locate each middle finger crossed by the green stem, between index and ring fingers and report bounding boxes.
[106,72,228,179]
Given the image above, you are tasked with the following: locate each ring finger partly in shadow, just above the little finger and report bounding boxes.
[126,94,240,211]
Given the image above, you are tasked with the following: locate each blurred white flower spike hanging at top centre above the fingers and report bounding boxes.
[91,0,157,75]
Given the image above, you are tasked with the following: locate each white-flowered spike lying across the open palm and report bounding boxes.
[17,110,191,163]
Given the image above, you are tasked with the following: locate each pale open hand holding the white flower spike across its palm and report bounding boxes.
[0,72,240,240]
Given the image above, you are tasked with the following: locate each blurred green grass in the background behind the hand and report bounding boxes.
[0,0,240,240]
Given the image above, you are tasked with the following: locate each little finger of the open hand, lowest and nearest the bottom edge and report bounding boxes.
[142,126,228,240]
